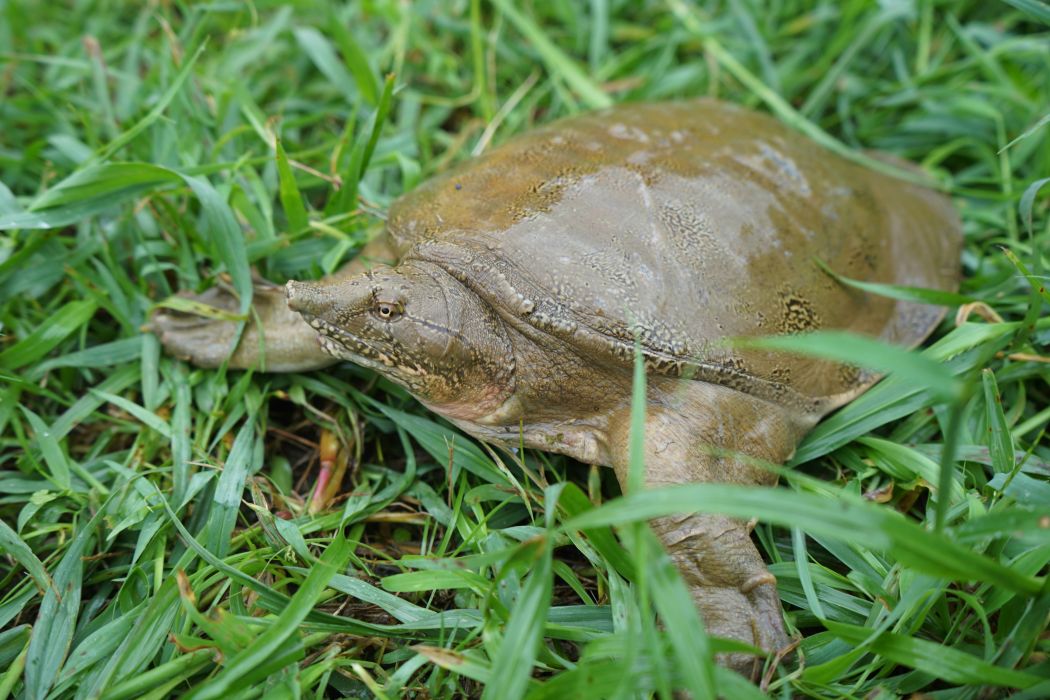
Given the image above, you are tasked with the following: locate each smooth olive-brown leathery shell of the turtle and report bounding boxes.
[389,100,961,411]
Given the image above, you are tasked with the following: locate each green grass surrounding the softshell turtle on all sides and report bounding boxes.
[0,0,1050,699]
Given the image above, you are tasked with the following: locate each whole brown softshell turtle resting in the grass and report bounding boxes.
[154,100,961,670]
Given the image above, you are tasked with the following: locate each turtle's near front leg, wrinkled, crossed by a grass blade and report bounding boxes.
[609,382,809,678]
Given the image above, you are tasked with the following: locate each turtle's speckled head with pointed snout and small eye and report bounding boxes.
[286,261,515,421]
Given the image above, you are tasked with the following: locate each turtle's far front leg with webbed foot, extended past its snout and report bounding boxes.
[149,280,337,372]
